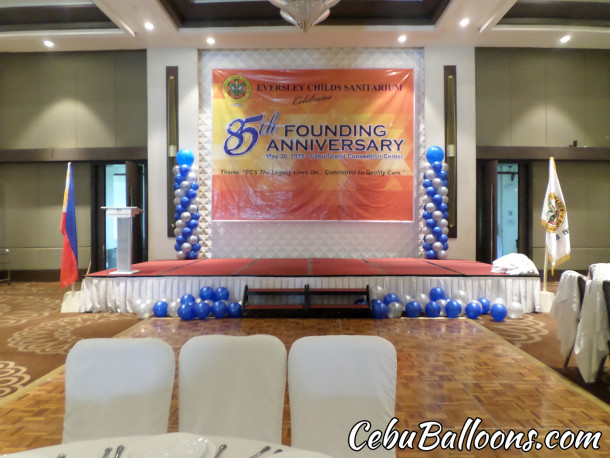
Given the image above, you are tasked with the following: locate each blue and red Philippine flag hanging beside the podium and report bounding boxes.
[59,162,78,288]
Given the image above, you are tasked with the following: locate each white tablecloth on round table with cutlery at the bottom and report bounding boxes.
[1,433,330,458]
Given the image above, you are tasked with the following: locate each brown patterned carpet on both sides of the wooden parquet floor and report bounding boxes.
[0,282,610,404]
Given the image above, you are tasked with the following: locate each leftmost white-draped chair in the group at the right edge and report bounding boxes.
[551,270,582,357]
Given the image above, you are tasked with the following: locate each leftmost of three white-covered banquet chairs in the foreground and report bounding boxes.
[63,338,176,443]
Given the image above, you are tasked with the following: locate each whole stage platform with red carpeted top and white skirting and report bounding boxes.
[79,258,540,313]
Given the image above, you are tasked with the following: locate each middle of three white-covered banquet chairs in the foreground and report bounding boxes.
[178,334,286,443]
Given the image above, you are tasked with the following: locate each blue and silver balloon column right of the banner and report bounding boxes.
[422,146,449,259]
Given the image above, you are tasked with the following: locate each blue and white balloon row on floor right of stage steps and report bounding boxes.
[371,286,523,321]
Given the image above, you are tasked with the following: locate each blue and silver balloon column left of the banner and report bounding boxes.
[172,149,201,259]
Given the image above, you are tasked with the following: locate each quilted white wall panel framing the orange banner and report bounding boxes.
[199,49,425,258]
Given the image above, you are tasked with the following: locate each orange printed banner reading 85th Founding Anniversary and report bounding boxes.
[212,69,414,221]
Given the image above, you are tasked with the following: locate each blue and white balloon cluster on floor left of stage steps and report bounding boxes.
[134,286,242,321]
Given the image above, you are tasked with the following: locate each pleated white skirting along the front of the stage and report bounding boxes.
[79,276,541,313]
